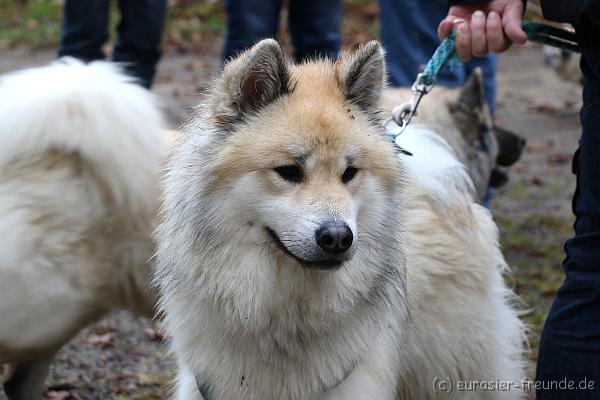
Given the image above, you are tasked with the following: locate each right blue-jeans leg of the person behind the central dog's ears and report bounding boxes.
[289,0,342,62]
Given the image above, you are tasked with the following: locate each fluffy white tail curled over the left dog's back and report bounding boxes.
[0,58,163,211]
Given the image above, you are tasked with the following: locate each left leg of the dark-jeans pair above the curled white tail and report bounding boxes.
[58,0,109,61]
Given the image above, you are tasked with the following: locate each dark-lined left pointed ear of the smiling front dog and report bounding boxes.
[211,39,291,125]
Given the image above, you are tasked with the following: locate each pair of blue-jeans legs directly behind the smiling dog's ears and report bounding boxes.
[223,0,342,62]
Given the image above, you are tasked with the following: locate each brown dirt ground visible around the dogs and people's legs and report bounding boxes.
[0,42,580,400]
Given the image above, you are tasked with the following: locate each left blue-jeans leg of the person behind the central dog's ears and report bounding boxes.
[222,0,282,62]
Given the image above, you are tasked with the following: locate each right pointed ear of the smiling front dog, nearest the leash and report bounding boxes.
[337,40,385,122]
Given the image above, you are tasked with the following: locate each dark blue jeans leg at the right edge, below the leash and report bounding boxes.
[537,51,600,400]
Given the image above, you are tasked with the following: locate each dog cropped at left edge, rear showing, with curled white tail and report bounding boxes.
[0,60,165,400]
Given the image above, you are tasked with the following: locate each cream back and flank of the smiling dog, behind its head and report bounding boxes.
[397,124,526,399]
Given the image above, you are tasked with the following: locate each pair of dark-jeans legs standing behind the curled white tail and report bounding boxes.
[58,0,166,87]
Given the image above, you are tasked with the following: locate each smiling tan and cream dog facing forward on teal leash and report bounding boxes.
[155,40,524,400]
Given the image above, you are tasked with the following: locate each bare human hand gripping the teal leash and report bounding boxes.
[438,0,527,61]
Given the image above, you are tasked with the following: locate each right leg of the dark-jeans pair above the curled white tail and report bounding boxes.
[113,0,167,88]
